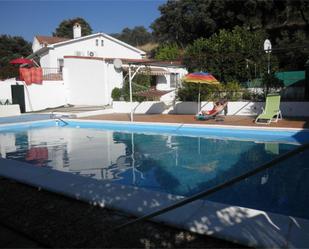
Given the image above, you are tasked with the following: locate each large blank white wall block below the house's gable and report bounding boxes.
[64,58,122,105]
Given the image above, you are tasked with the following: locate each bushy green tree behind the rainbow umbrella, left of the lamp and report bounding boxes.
[184,27,277,82]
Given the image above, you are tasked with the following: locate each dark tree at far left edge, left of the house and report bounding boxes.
[0,35,32,79]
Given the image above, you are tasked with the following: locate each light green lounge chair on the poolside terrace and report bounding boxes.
[255,94,282,124]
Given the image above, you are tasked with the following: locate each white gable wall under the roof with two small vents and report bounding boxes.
[40,36,142,67]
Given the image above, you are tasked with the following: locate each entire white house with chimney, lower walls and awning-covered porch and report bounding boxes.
[0,24,187,112]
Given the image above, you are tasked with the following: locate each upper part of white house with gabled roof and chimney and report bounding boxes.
[31,23,146,68]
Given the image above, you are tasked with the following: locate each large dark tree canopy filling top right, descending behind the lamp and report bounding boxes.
[151,0,309,70]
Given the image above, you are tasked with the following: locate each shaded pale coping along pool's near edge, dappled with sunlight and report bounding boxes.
[0,159,309,248]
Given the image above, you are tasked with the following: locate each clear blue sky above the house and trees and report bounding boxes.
[0,0,166,42]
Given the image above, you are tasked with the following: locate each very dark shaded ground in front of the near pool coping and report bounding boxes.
[0,178,243,248]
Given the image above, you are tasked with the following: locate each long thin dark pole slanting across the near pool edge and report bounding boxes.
[114,143,309,230]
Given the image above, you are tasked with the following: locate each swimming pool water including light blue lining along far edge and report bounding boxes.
[0,122,309,218]
